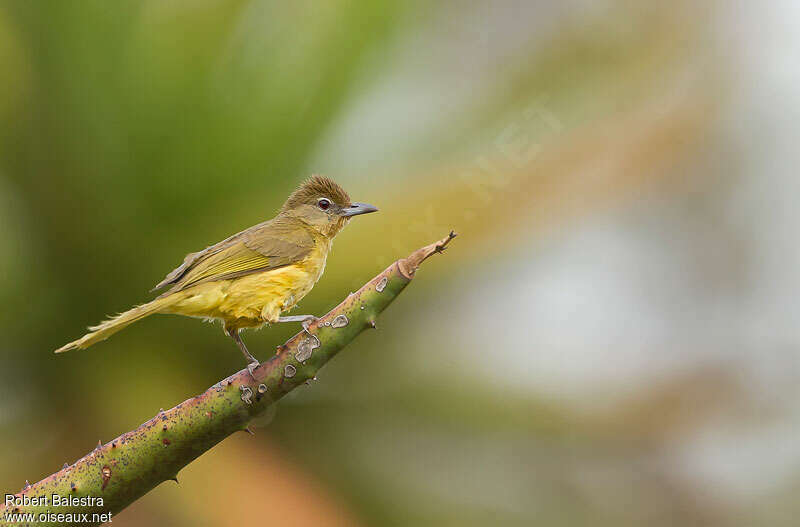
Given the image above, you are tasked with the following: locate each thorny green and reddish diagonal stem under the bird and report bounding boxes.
[0,232,456,525]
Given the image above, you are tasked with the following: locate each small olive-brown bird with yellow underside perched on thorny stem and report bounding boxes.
[56,176,378,373]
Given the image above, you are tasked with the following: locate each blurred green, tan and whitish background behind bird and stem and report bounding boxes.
[0,0,800,526]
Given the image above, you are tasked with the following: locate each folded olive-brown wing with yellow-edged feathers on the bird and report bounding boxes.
[156,222,314,293]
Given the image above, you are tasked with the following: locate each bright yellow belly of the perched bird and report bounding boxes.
[164,255,325,329]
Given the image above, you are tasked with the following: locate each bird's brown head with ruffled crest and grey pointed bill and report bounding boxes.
[280,176,378,238]
